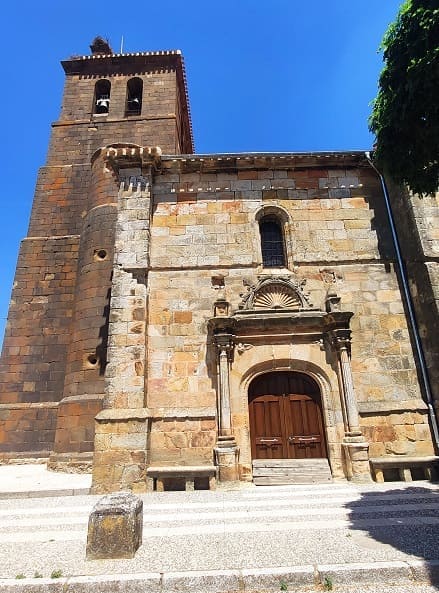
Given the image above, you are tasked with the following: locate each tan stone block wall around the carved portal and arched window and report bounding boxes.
[147,158,432,462]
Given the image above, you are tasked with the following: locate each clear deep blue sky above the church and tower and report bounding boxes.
[0,0,400,341]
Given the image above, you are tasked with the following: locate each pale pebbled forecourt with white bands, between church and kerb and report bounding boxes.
[0,482,439,580]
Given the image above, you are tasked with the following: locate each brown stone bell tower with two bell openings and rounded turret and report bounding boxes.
[0,37,193,467]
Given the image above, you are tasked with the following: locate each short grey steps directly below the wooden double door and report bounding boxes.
[253,459,332,486]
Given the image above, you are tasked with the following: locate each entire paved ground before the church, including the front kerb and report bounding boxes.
[0,480,439,593]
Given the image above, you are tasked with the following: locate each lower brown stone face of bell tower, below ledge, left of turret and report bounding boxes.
[0,236,79,452]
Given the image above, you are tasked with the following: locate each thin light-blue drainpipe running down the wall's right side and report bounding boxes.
[364,152,439,452]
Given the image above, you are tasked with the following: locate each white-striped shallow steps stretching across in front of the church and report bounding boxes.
[0,486,439,541]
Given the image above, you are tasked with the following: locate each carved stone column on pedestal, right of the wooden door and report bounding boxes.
[330,329,371,482]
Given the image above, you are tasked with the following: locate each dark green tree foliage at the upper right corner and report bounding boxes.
[369,0,439,194]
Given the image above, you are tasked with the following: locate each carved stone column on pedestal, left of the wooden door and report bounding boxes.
[214,333,239,482]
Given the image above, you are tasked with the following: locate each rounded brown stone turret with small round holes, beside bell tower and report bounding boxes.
[49,151,122,469]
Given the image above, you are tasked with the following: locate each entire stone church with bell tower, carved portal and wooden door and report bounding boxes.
[0,38,439,493]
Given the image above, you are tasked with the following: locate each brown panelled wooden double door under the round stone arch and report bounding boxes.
[249,371,327,459]
